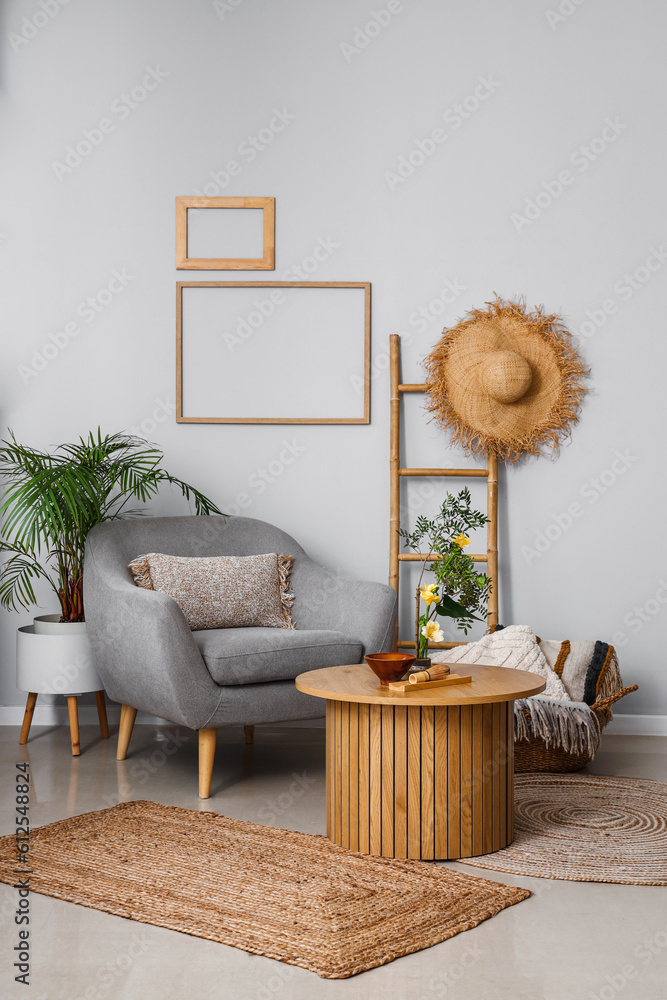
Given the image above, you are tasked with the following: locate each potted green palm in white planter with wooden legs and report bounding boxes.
[0,429,225,754]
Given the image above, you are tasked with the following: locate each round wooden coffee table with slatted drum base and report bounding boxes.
[296,663,546,860]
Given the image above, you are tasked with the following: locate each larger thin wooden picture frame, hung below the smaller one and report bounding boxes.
[176,281,371,424]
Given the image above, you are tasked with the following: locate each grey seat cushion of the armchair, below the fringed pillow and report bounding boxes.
[192,628,363,686]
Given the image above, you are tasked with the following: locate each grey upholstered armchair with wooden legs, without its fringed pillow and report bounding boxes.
[84,517,396,798]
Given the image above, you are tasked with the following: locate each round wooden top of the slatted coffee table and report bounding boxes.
[296,663,546,705]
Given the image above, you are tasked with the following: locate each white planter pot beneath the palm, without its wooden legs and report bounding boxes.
[16,615,104,695]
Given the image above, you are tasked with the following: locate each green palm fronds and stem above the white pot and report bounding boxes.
[0,428,224,622]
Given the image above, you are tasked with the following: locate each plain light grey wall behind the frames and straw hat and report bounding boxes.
[0,0,667,715]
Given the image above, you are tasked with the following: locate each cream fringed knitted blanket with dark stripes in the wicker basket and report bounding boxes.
[431,625,608,759]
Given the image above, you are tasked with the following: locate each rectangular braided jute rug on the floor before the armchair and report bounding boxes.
[0,801,530,979]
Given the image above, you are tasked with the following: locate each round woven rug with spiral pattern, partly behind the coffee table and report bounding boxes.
[461,774,667,885]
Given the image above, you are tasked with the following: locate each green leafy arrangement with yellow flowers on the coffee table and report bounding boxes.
[399,487,491,662]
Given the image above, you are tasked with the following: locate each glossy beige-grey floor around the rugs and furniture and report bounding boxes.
[0,726,667,1000]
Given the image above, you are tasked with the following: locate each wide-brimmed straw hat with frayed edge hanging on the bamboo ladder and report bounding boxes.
[424,298,590,463]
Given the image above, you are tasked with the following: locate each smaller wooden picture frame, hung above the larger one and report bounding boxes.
[176,196,276,271]
